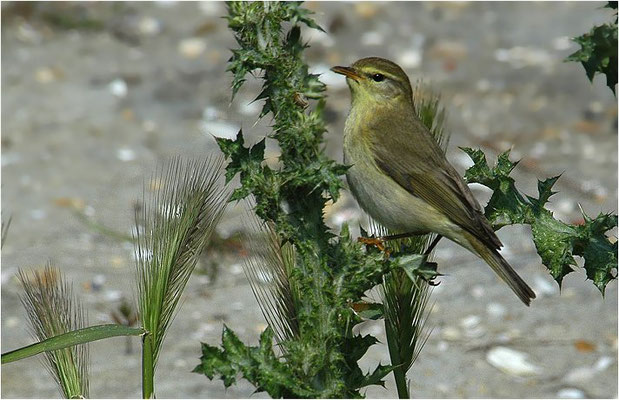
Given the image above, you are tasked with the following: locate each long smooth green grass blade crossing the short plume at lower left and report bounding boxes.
[2,324,145,364]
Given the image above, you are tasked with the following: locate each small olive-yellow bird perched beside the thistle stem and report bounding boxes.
[331,57,535,305]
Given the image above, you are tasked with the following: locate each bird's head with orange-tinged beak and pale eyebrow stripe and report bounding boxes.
[331,57,412,105]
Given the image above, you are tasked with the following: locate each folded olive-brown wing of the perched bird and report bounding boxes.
[371,112,502,249]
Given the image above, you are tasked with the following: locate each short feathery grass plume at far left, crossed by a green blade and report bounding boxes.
[18,264,89,399]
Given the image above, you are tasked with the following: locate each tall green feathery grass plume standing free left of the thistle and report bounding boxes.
[135,157,229,395]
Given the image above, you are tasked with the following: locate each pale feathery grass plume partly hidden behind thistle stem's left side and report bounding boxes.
[243,215,300,350]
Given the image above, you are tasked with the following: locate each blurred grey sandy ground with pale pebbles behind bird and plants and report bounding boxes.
[1,1,617,398]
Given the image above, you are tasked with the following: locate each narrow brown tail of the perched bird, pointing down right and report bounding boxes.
[466,234,535,306]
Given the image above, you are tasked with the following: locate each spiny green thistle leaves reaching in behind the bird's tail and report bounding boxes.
[463,149,617,293]
